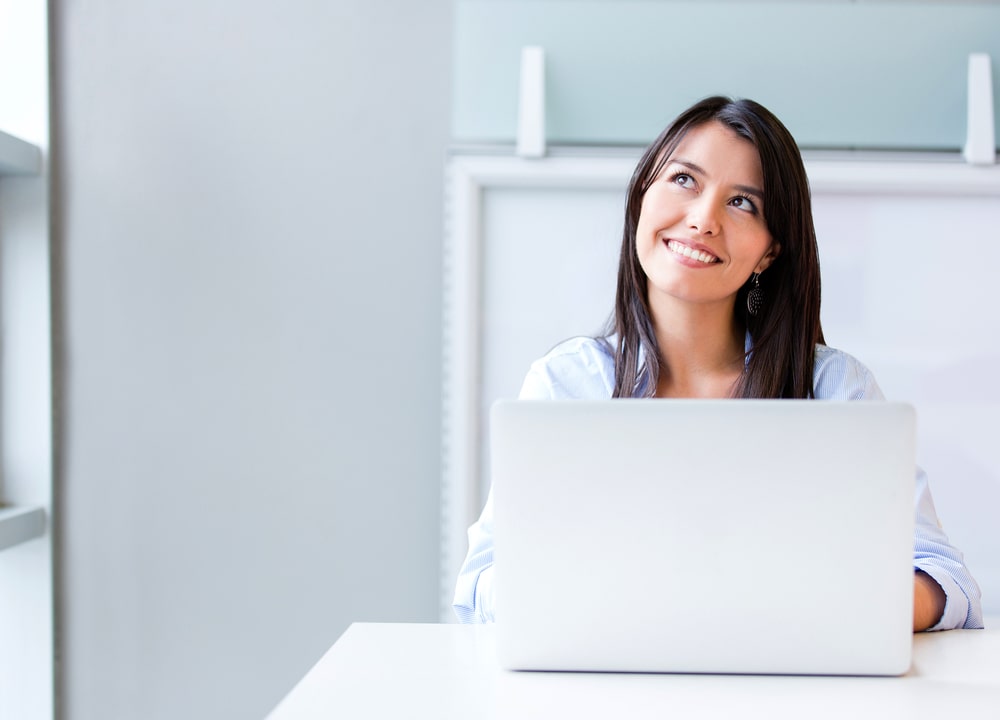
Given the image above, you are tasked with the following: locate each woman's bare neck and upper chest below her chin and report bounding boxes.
[653,303,746,398]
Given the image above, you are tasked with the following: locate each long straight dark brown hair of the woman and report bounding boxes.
[609,97,824,398]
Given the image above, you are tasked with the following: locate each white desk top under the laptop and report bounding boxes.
[269,618,1000,720]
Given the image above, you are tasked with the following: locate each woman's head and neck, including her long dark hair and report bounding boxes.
[609,97,823,398]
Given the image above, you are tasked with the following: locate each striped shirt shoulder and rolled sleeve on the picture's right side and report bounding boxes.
[815,347,983,630]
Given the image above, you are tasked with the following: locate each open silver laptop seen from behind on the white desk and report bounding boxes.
[490,400,915,675]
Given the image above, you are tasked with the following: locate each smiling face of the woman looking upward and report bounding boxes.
[636,121,779,316]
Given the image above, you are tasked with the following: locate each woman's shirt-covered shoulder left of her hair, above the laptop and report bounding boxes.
[520,336,615,400]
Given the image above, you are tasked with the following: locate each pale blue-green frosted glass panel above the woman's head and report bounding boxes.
[452,0,1000,150]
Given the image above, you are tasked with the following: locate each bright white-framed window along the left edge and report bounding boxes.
[0,0,56,720]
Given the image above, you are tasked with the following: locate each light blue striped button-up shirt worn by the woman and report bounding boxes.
[454,337,983,630]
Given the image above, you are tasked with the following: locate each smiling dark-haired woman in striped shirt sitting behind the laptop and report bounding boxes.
[455,97,982,631]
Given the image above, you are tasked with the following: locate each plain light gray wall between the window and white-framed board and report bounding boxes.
[51,0,452,720]
